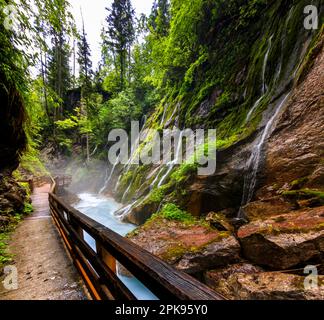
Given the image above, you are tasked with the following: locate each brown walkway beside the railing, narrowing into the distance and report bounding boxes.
[0,184,86,300]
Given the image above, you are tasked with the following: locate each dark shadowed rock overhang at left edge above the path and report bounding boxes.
[0,24,27,228]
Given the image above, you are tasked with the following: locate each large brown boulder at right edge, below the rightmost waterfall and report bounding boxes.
[238,207,324,270]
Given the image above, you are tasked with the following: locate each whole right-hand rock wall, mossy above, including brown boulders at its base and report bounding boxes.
[100,1,324,299]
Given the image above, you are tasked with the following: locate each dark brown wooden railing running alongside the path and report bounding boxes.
[49,179,225,300]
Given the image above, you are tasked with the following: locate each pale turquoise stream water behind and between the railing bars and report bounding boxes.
[75,193,157,300]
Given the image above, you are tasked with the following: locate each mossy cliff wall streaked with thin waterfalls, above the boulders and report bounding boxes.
[112,0,323,220]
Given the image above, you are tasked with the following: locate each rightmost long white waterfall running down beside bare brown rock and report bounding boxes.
[238,93,290,219]
